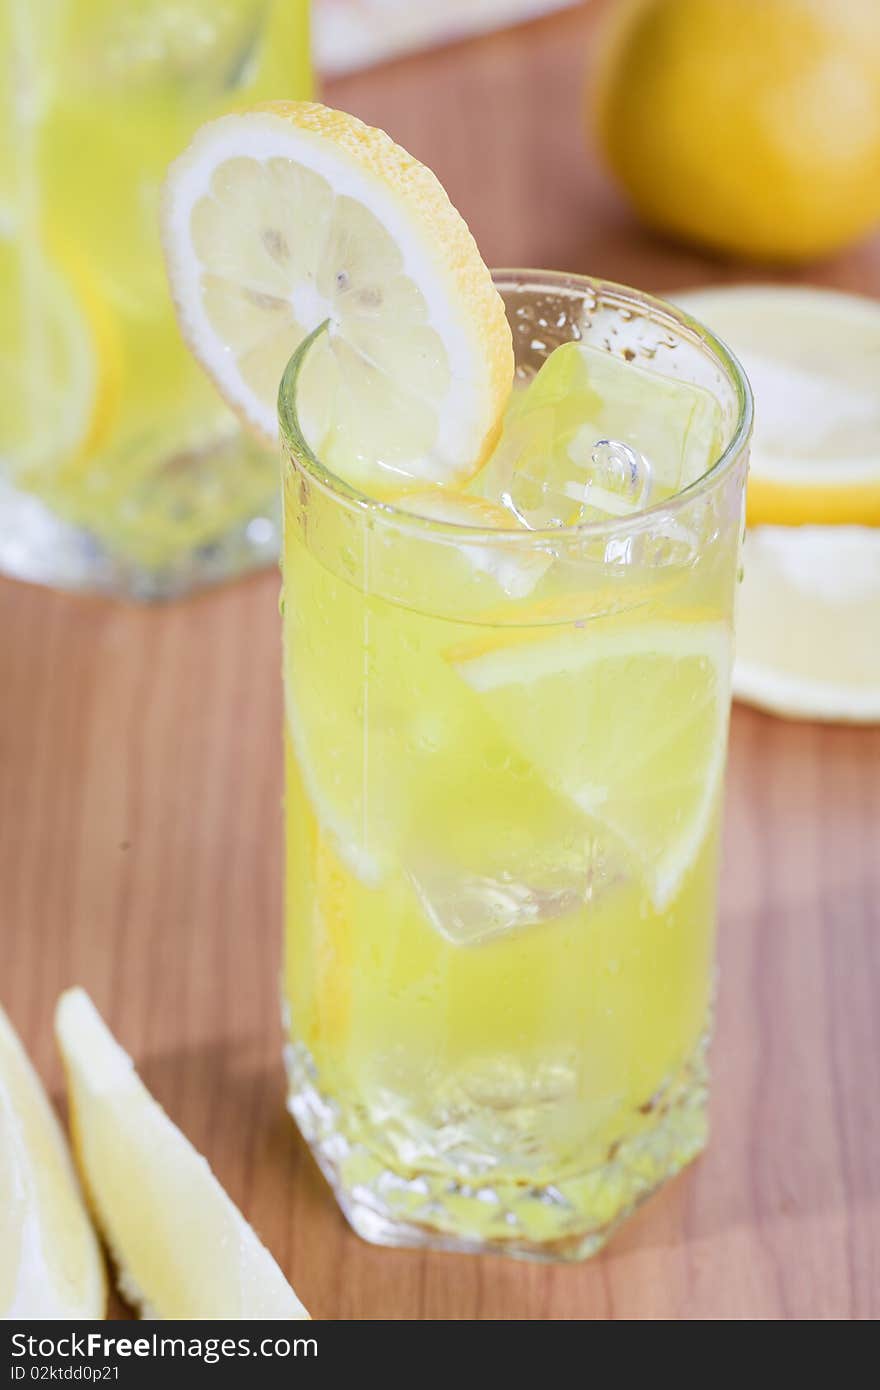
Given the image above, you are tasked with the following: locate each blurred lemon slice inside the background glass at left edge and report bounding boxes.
[0,239,121,484]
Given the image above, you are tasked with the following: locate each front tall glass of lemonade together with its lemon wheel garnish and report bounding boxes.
[156,101,751,1258]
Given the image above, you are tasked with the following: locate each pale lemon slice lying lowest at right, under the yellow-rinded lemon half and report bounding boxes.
[733,525,880,723]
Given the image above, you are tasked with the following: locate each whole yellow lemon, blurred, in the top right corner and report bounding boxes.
[596,0,880,263]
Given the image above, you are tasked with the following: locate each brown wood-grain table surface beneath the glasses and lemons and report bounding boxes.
[0,0,880,1319]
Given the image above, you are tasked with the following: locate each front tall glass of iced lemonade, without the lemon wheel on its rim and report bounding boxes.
[279,272,751,1259]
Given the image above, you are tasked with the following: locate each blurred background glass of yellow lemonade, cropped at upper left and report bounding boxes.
[0,0,310,598]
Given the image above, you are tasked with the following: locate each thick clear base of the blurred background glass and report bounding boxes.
[0,480,281,602]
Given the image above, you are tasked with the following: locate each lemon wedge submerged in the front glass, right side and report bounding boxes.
[449,621,730,910]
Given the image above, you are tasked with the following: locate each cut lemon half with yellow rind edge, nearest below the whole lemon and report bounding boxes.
[674,285,880,525]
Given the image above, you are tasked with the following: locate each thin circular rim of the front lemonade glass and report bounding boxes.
[278,267,753,546]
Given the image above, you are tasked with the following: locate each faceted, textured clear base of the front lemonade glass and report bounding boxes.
[285,1040,708,1261]
